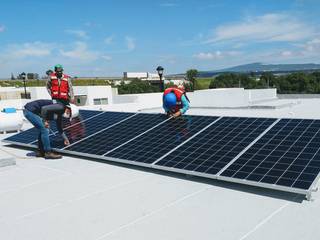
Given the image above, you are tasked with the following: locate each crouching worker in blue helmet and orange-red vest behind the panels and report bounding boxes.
[162,86,190,118]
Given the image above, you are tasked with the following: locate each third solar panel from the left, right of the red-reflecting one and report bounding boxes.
[65,113,167,156]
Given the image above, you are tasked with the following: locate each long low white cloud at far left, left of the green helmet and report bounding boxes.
[6,42,55,59]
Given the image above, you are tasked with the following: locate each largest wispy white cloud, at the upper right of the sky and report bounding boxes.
[205,14,316,43]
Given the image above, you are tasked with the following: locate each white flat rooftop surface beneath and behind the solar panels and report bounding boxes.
[0,96,320,240]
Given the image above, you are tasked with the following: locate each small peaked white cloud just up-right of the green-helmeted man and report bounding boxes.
[60,42,99,62]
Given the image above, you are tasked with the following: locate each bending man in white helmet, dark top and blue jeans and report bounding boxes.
[23,100,79,159]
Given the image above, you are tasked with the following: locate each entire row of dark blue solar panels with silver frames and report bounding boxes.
[5,110,320,198]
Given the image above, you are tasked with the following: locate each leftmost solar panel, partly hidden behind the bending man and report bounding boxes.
[5,110,100,144]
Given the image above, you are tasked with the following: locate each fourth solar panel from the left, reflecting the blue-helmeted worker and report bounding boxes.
[106,116,217,164]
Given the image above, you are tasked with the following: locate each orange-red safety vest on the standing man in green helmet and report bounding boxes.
[50,73,69,100]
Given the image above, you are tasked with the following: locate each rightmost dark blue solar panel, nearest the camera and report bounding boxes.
[221,119,320,190]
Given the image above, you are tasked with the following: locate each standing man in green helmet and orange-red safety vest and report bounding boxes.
[47,64,74,105]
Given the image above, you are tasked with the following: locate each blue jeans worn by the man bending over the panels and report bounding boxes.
[23,109,51,153]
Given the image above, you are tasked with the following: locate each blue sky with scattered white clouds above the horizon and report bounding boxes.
[0,0,320,78]
